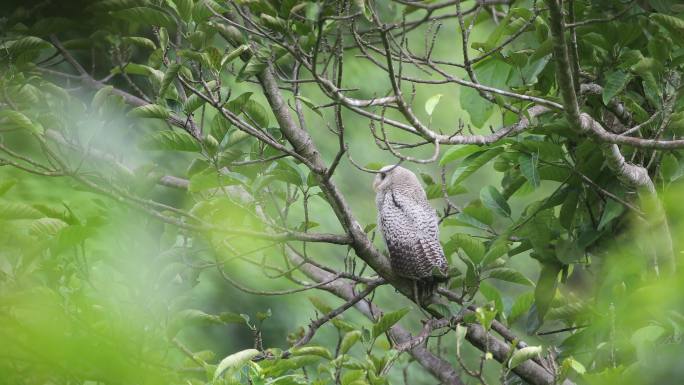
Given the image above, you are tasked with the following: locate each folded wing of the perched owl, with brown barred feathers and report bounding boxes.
[390,192,448,277]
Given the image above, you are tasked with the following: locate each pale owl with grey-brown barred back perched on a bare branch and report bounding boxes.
[373,166,448,302]
